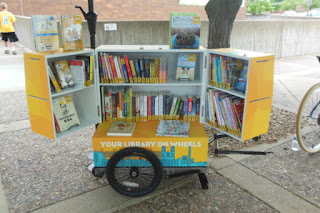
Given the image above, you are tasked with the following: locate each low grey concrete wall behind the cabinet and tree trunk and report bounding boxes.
[16,17,320,58]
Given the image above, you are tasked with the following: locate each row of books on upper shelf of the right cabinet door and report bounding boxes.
[210,54,248,93]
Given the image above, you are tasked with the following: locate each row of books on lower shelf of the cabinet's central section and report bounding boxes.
[101,88,200,121]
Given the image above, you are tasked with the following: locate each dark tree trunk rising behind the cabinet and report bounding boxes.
[205,0,242,49]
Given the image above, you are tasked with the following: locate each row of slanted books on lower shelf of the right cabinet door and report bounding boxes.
[206,89,244,136]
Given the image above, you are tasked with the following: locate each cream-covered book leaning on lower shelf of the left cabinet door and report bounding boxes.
[52,95,80,132]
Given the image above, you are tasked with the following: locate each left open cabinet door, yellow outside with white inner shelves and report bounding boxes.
[24,50,101,140]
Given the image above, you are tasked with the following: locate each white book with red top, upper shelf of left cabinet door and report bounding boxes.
[69,60,87,86]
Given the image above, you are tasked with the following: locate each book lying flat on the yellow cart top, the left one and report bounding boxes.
[107,121,136,136]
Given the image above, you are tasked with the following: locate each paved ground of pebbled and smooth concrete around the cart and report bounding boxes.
[0,40,320,213]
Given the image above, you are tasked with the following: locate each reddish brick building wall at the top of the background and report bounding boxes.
[7,0,246,21]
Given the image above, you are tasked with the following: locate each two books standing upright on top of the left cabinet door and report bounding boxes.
[31,15,84,52]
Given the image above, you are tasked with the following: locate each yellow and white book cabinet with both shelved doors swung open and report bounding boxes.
[24,45,274,141]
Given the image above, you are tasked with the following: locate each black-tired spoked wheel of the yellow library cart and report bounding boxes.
[106,147,163,197]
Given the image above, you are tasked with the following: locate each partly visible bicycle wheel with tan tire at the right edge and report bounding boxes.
[296,83,320,153]
